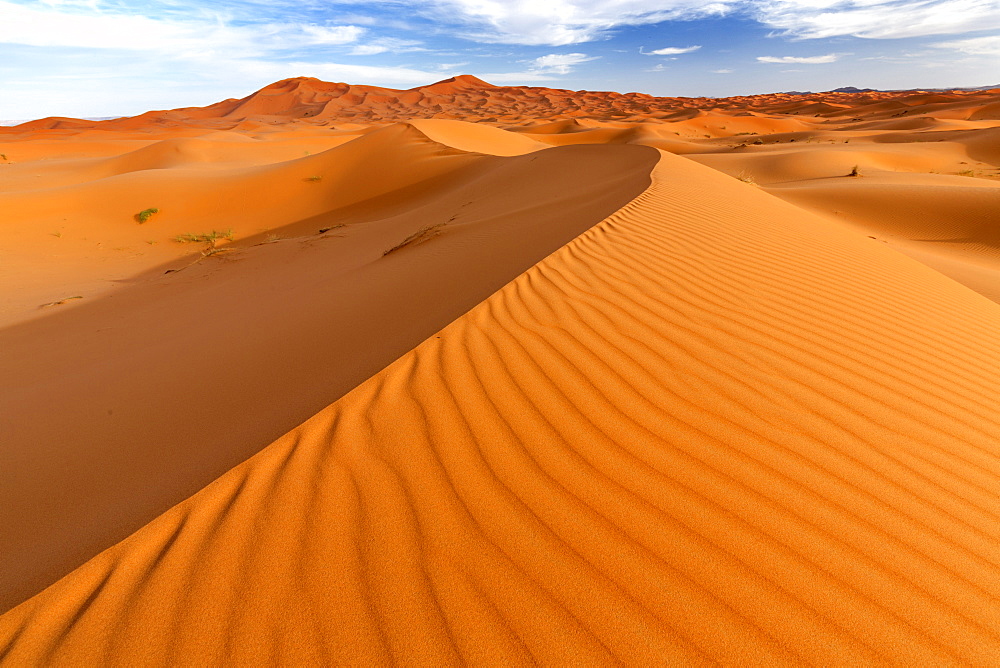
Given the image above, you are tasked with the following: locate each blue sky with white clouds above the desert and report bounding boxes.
[0,0,1000,120]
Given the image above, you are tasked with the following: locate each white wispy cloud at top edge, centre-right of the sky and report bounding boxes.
[424,0,738,46]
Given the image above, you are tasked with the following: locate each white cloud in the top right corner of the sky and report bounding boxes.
[750,0,1000,39]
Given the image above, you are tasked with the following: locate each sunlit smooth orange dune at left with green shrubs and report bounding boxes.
[0,125,466,323]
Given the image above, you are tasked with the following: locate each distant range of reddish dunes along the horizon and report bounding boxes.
[0,75,1000,131]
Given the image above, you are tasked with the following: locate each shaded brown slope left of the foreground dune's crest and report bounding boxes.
[0,127,658,610]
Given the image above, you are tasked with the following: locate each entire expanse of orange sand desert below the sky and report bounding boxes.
[0,77,1000,666]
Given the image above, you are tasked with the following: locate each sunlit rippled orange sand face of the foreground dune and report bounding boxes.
[0,154,1000,665]
